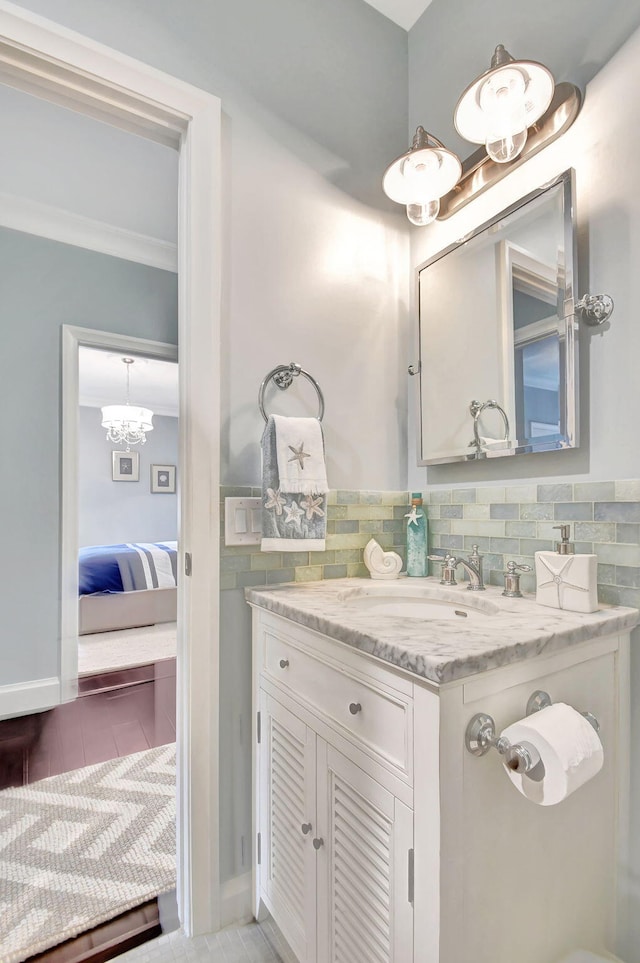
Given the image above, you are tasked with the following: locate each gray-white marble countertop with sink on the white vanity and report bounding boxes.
[245,578,640,685]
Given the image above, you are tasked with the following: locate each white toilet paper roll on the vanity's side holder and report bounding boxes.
[501,702,604,806]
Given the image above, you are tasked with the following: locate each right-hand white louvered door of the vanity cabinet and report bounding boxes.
[317,738,413,963]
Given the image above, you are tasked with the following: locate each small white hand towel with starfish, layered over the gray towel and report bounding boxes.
[273,415,329,495]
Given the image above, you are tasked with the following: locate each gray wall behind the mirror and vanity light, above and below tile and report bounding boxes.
[408,11,640,963]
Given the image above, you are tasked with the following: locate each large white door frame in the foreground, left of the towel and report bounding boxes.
[0,0,221,936]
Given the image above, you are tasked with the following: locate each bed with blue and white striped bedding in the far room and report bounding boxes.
[78,541,178,635]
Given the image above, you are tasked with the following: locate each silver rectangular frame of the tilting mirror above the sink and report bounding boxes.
[418,168,579,466]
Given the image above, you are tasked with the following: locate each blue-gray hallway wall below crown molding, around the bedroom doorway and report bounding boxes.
[0,229,177,685]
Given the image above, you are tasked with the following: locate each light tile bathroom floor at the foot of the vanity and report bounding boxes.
[118,920,297,963]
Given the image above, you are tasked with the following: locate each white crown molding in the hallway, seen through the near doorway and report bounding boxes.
[0,193,178,274]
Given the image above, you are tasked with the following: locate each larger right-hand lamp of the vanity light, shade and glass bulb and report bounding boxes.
[453,44,555,164]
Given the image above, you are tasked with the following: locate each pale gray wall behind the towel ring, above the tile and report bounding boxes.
[13,0,408,489]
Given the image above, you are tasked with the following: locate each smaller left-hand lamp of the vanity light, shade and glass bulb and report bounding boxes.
[382,127,462,227]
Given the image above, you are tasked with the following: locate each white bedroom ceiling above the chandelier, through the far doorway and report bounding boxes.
[78,345,178,418]
